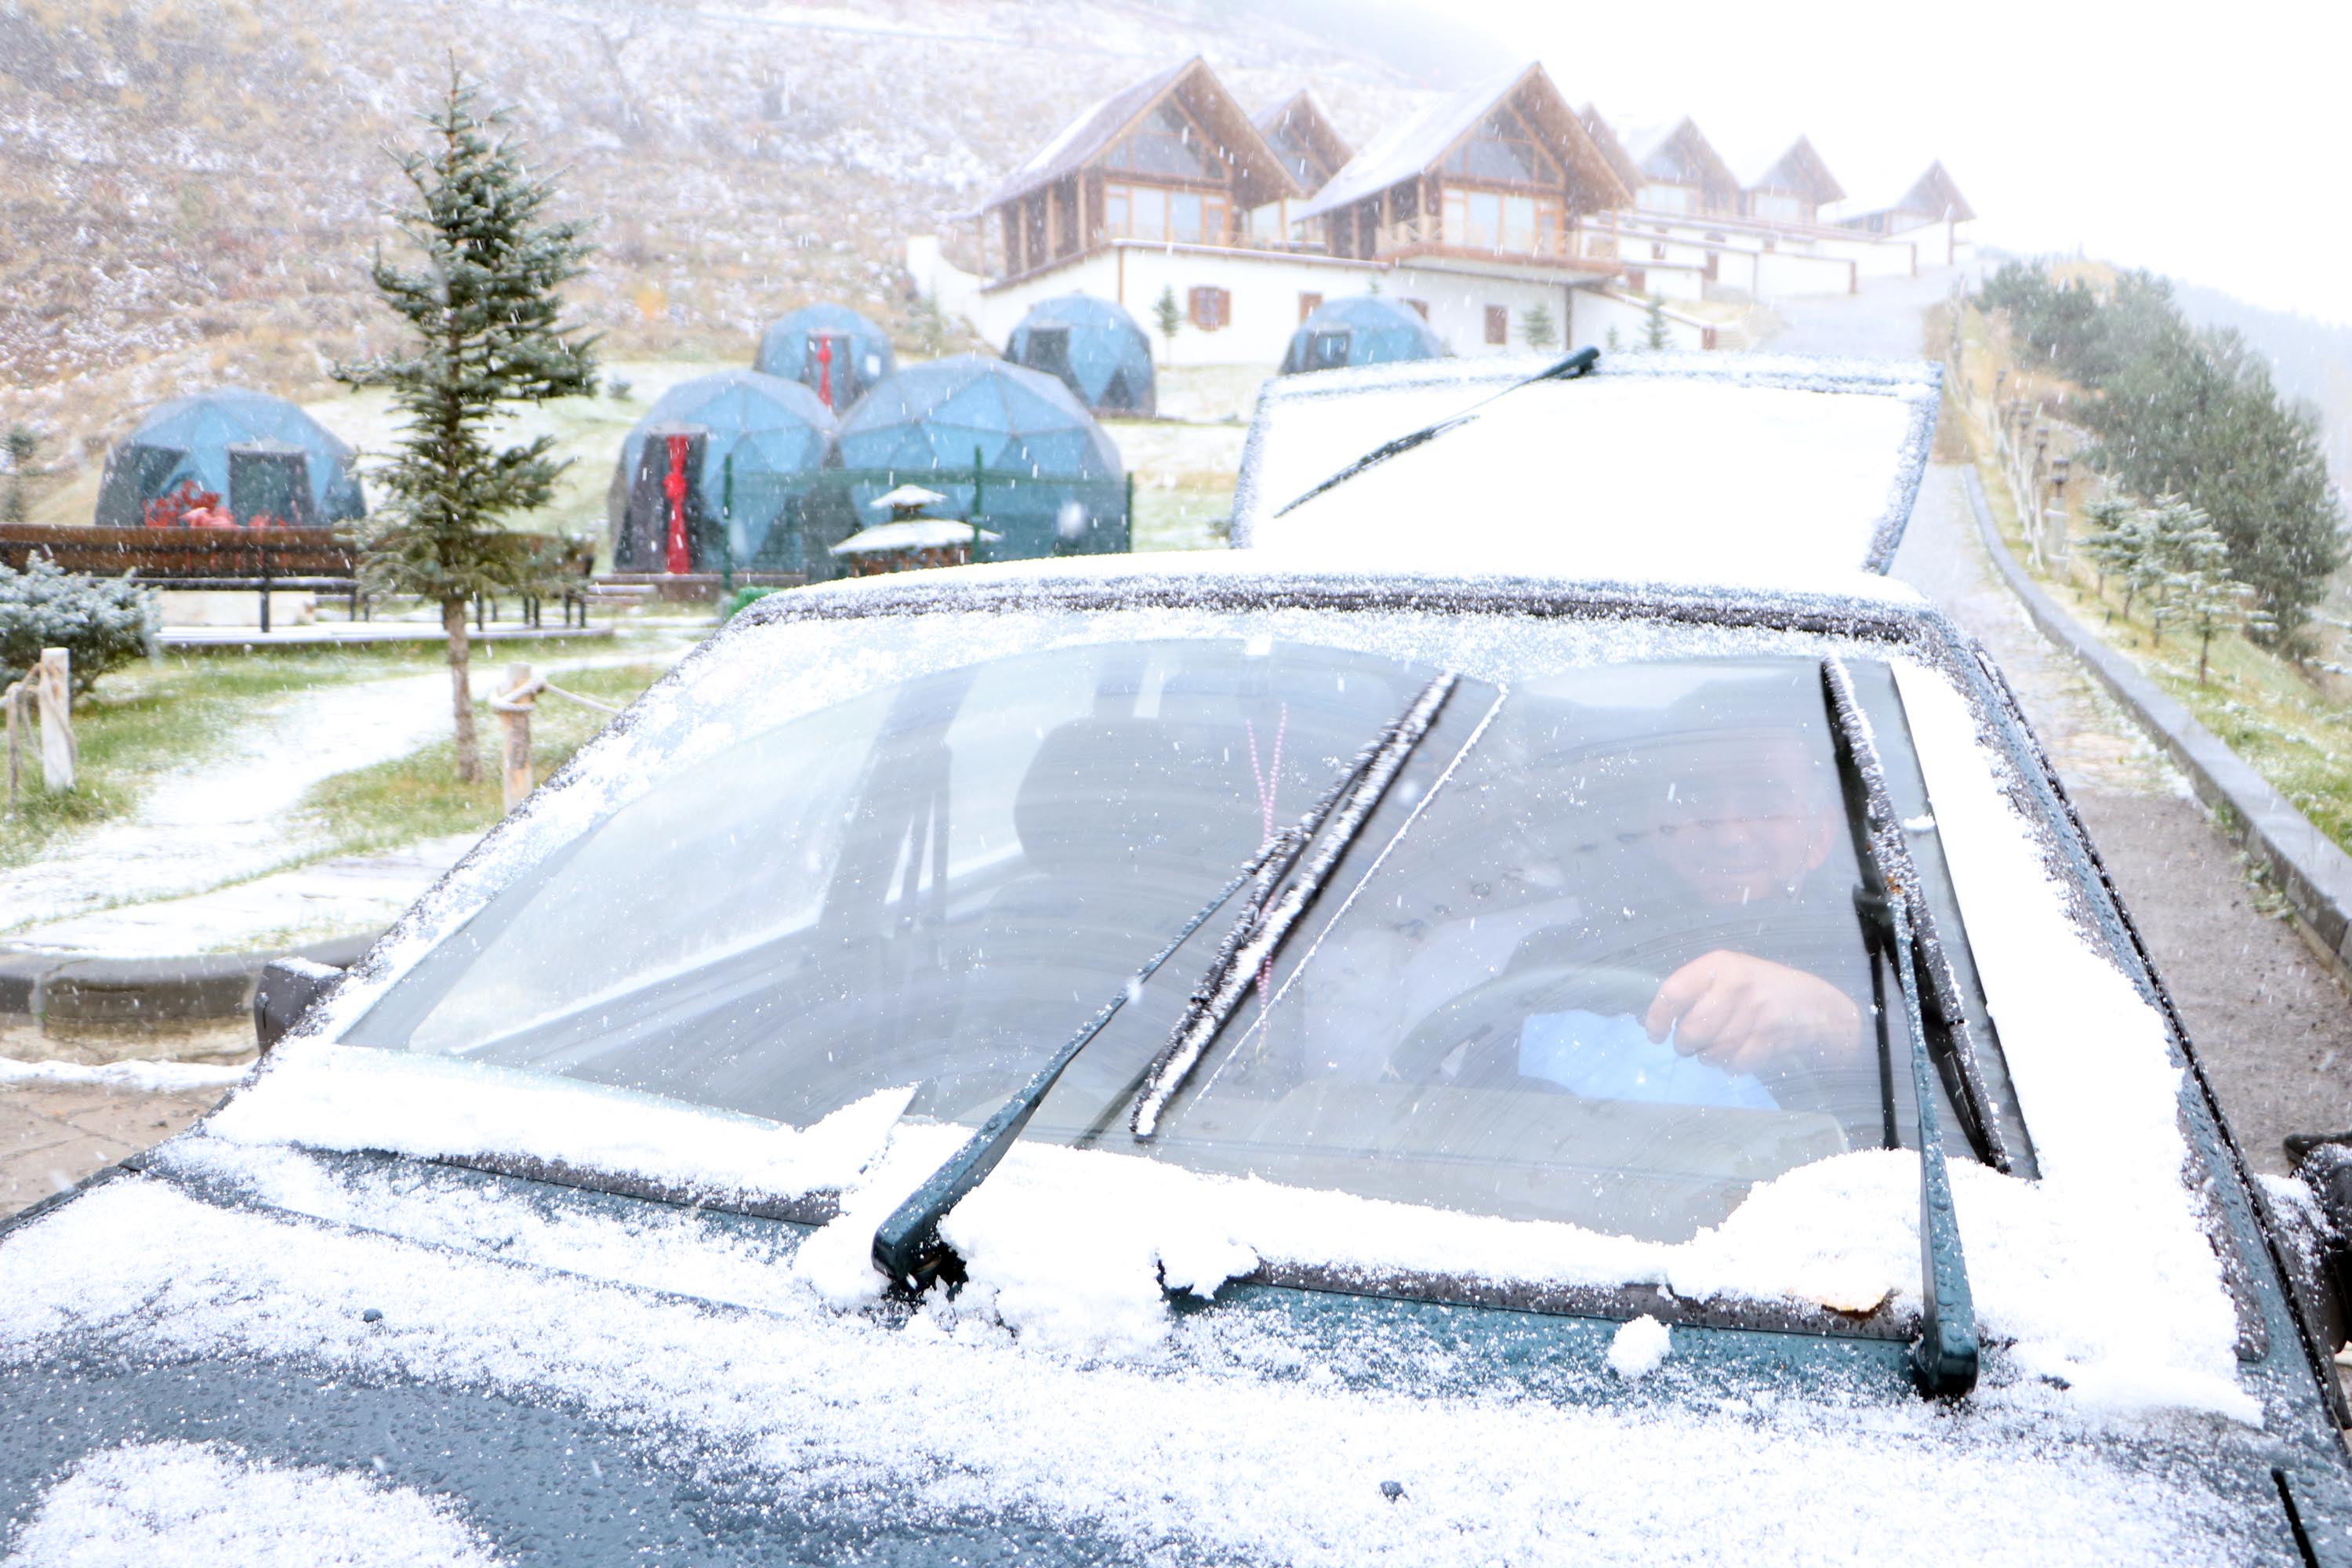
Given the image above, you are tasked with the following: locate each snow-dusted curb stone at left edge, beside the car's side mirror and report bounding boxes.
[0,933,376,1025]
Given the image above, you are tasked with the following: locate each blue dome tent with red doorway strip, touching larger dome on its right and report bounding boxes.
[607,369,833,572]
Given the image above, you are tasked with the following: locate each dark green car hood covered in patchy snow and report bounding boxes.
[0,1135,2324,1563]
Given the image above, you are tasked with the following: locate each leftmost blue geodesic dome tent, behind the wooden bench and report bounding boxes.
[92,386,367,529]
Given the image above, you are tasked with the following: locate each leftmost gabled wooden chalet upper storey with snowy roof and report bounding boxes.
[981,56,1303,280]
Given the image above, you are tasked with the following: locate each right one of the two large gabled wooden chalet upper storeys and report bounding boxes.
[1298,66,1632,273]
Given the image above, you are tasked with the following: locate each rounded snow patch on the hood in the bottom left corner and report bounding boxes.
[0,1443,494,1568]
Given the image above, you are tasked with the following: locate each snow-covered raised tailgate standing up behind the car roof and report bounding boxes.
[1232,353,1940,588]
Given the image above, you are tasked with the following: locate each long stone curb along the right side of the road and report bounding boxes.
[1962,466,2352,980]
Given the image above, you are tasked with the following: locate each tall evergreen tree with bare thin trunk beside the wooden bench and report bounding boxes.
[334,64,595,783]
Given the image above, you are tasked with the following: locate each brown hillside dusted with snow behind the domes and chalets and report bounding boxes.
[0,0,1416,491]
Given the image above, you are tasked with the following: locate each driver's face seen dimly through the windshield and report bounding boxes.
[1656,734,1842,909]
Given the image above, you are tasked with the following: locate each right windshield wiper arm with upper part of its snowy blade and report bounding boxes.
[1820,659,1978,1396]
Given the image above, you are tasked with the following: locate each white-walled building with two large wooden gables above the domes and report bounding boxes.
[908,59,1665,365]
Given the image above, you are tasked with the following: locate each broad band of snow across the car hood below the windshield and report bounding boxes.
[0,1178,2267,1568]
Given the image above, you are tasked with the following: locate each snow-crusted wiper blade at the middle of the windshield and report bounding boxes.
[1127,673,1458,1138]
